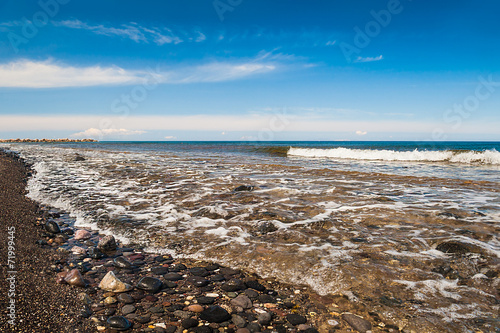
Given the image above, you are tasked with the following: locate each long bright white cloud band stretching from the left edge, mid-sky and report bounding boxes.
[0,58,279,88]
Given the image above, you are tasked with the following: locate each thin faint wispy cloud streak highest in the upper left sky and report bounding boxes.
[53,20,206,45]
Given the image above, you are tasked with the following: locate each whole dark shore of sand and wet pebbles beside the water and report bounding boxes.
[0,149,398,333]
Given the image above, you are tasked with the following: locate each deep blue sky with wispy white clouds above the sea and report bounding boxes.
[0,0,500,141]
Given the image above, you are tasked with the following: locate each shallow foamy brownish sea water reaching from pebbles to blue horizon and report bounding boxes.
[0,142,500,332]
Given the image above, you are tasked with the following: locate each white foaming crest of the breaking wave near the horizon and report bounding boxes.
[288,147,500,164]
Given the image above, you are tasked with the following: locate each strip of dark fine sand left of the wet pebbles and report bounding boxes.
[0,152,94,333]
